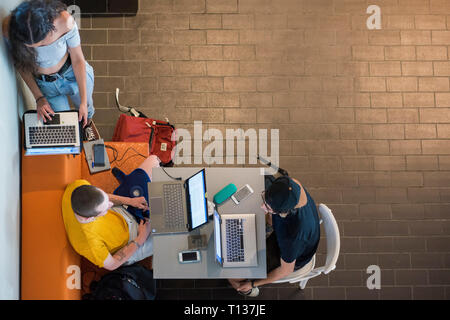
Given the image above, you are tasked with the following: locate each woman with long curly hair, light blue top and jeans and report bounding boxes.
[2,0,94,127]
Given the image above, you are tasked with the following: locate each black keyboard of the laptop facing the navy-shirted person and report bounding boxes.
[225,219,245,262]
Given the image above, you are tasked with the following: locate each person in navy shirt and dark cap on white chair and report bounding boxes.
[229,176,320,297]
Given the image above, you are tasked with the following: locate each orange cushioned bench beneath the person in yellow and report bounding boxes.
[21,142,148,300]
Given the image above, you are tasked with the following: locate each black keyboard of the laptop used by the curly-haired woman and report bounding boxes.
[28,126,77,145]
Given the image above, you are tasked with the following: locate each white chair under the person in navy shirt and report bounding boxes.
[274,204,341,289]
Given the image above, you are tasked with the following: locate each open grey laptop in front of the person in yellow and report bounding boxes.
[148,169,208,234]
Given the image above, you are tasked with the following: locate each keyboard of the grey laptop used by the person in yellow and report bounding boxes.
[163,184,186,229]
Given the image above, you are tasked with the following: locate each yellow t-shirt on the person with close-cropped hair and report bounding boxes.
[62,180,129,268]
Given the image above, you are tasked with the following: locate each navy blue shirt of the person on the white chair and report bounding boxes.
[272,188,320,269]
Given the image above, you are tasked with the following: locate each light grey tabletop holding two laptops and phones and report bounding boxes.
[152,167,267,279]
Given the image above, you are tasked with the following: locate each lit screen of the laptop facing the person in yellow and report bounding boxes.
[187,170,208,229]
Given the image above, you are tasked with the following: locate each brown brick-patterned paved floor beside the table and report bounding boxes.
[81,0,450,299]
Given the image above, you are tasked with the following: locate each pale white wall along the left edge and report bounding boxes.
[0,0,27,300]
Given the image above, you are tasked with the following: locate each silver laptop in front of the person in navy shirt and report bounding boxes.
[214,211,258,268]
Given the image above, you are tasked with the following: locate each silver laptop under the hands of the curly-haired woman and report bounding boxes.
[23,110,81,156]
